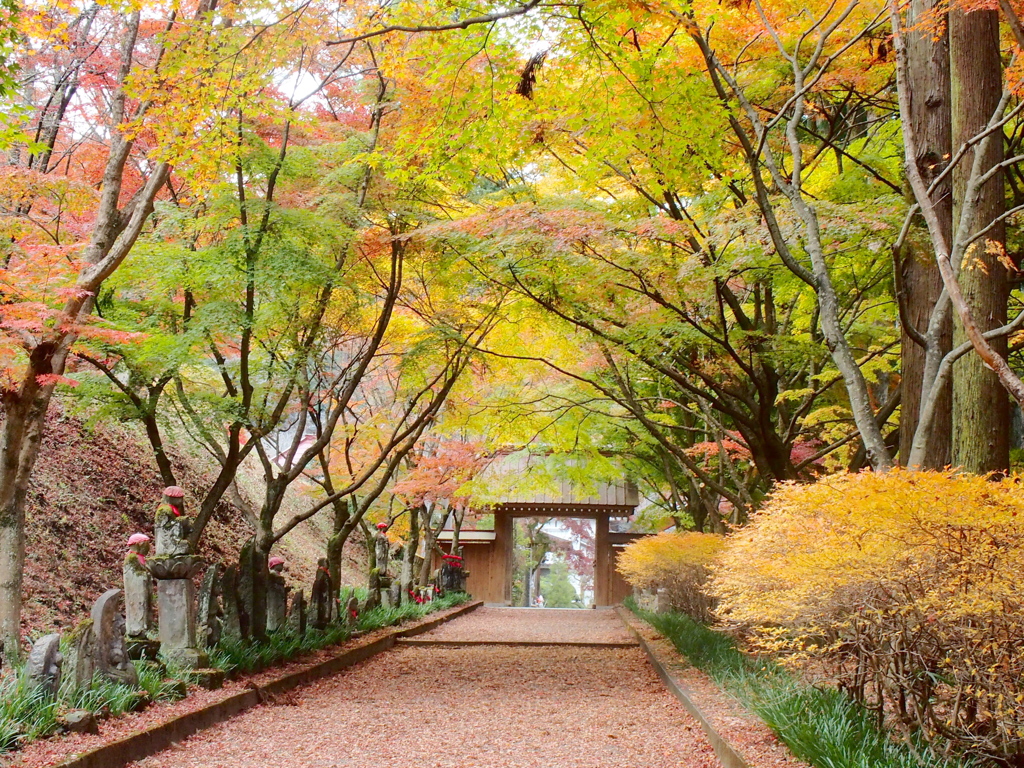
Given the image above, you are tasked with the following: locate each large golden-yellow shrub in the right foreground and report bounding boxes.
[710,471,1024,757]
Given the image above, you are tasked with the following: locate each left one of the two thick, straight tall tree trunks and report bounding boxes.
[899,0,953,469]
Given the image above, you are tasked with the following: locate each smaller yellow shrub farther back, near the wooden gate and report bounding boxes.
[616,532,725,622]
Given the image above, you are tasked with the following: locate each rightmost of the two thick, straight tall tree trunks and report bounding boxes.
[949,8,1010,473]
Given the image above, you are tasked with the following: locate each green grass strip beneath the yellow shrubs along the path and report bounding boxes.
[627,600,973,768]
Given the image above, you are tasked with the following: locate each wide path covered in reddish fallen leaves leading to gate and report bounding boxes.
[135,609,719,768]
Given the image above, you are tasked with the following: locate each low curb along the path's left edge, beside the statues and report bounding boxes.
[48,600,483,768]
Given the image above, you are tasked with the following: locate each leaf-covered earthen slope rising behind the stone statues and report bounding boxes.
[23,408,359,638]
